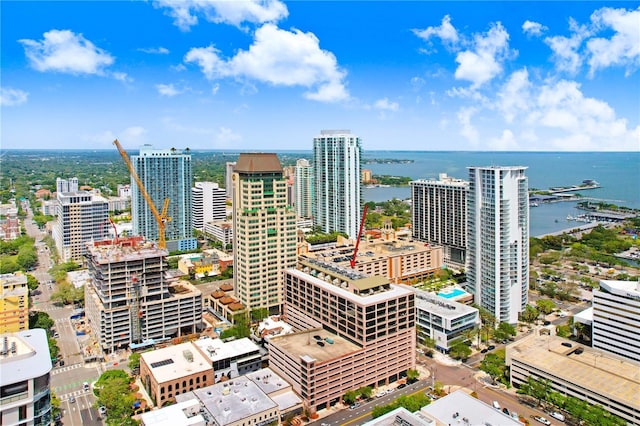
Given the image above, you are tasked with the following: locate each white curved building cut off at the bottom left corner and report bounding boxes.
[0,328,52,426]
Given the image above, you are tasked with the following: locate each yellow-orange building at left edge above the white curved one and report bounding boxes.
[0,272,29,333]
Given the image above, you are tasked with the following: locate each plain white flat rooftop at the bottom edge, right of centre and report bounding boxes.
[420,390,522,426]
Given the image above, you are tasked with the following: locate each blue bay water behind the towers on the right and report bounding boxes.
[362,151,640,237]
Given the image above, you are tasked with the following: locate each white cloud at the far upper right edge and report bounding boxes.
[586,7,640,75]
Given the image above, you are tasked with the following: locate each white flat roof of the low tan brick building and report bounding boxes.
[141,342,211,383]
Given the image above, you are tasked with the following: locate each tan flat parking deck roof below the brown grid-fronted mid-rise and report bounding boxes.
[270,328,361,362]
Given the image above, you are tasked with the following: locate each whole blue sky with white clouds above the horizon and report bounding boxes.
[0,0,640,151]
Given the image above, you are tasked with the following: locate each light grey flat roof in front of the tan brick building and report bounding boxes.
[176,376,278,426]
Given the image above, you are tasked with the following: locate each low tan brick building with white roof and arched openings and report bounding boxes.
[140,342,214,406]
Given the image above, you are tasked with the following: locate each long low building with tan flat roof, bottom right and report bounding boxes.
[506,333,640,426]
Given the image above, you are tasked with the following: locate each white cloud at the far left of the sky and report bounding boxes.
[19,30,114,75]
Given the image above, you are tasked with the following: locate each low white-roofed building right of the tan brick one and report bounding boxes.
[193,337,262,383]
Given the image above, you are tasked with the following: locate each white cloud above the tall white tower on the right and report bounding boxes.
[455,22,512,87]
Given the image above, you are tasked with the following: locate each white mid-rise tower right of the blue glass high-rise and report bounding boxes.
[191,182,227,231]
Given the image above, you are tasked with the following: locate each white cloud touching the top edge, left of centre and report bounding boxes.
[154,0,289,31]
